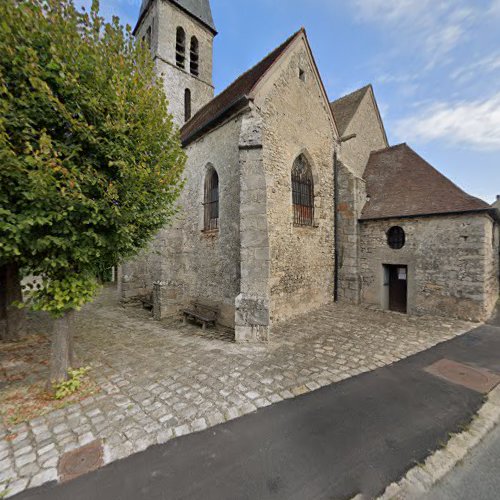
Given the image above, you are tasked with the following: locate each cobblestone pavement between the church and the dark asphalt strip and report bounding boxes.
[0,289,475,496]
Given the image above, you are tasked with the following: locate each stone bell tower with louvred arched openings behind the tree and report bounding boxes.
[134,0,217,126]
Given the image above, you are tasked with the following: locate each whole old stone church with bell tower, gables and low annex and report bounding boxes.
[120,0,499,342]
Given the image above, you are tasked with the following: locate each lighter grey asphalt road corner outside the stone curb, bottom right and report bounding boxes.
[426,420,500,500]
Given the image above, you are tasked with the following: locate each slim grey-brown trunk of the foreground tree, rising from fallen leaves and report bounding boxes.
[49,311,75,389]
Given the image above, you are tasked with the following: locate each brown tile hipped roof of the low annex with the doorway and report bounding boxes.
[360,144,493,220]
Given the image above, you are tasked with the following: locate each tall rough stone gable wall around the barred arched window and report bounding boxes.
[261,45,334,322]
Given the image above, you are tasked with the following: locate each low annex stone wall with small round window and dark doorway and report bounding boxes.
[360,214,498,321]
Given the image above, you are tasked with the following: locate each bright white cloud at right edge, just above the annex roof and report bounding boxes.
[396,92,500,151]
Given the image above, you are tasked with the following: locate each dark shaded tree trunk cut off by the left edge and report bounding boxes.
[0,262,26,341]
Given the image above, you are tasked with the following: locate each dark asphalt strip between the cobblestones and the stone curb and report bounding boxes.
[15,326,500,500]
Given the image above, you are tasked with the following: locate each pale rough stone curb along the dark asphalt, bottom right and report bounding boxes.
[378,386,500,500]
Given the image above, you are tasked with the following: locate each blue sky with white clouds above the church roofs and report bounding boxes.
[80,0,500,203]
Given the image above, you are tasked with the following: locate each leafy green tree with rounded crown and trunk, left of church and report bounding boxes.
[0,0,185,381]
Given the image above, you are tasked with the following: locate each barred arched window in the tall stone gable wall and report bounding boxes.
[292,154,314,226]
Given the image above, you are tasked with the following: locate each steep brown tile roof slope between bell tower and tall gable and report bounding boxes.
[181,28,304,145]
